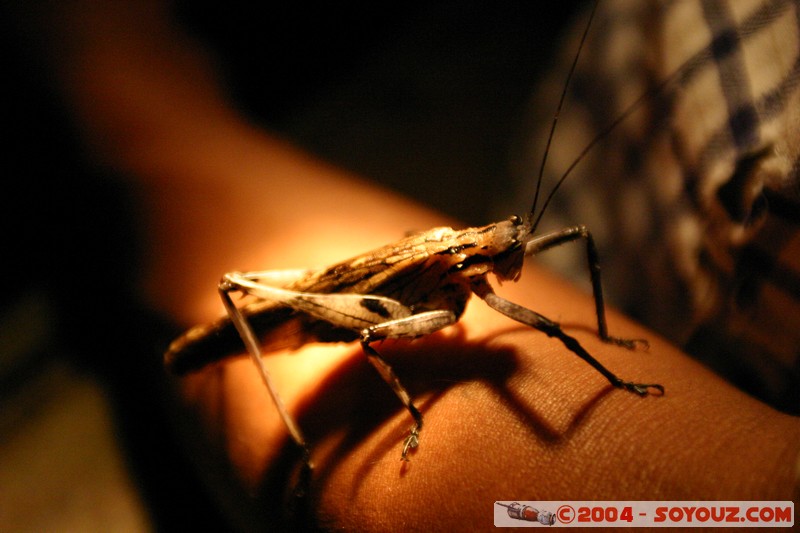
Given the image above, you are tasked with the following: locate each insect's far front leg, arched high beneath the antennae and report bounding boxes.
[525,224,649,349]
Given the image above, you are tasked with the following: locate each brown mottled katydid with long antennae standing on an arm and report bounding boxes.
[165,0,664,464]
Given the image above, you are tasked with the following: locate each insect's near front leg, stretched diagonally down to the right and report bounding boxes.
[473,281,664,396]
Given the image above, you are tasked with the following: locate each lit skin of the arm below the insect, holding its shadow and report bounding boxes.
[164,191,800,530]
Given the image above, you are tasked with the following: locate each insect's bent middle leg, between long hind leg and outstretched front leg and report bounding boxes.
[361,311,456,461]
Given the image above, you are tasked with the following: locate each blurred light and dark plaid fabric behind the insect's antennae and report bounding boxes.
[515,0,800,413]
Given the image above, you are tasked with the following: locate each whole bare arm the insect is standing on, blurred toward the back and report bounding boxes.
[14,2,800,531]
